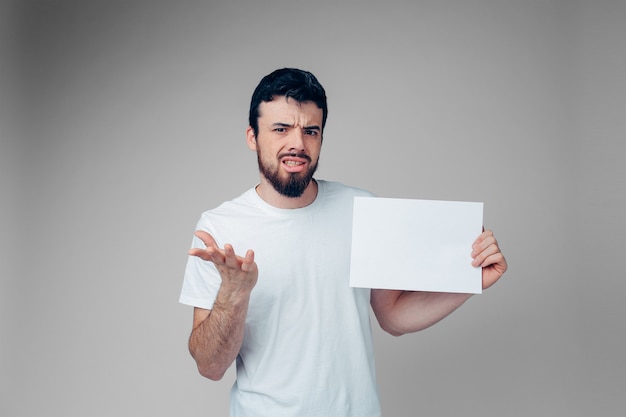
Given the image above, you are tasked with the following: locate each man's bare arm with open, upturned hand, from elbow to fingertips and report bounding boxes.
[189,231,258,381]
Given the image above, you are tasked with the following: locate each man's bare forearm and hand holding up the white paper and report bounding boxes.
[371,230,507,336]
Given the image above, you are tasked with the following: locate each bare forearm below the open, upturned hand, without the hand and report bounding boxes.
[189,290,249,381]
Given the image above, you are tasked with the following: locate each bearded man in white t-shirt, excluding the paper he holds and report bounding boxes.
[180,68,507,417]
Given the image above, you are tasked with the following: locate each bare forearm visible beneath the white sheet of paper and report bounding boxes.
[372,290,471,336]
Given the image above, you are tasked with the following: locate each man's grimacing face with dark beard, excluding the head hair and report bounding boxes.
[248,97,323,197]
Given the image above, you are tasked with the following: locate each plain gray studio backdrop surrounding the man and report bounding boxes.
[0,0,626,416]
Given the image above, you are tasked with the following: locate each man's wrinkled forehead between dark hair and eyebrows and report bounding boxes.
[259,96,323,126]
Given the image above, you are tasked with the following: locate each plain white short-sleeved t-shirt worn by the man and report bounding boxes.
[180,181,380,417]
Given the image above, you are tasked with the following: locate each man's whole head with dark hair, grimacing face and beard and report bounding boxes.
[246,68,327,198]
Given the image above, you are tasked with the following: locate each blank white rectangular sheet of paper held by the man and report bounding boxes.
[350,197,483,294]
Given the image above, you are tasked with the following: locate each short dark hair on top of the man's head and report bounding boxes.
[248,68,328,135]
